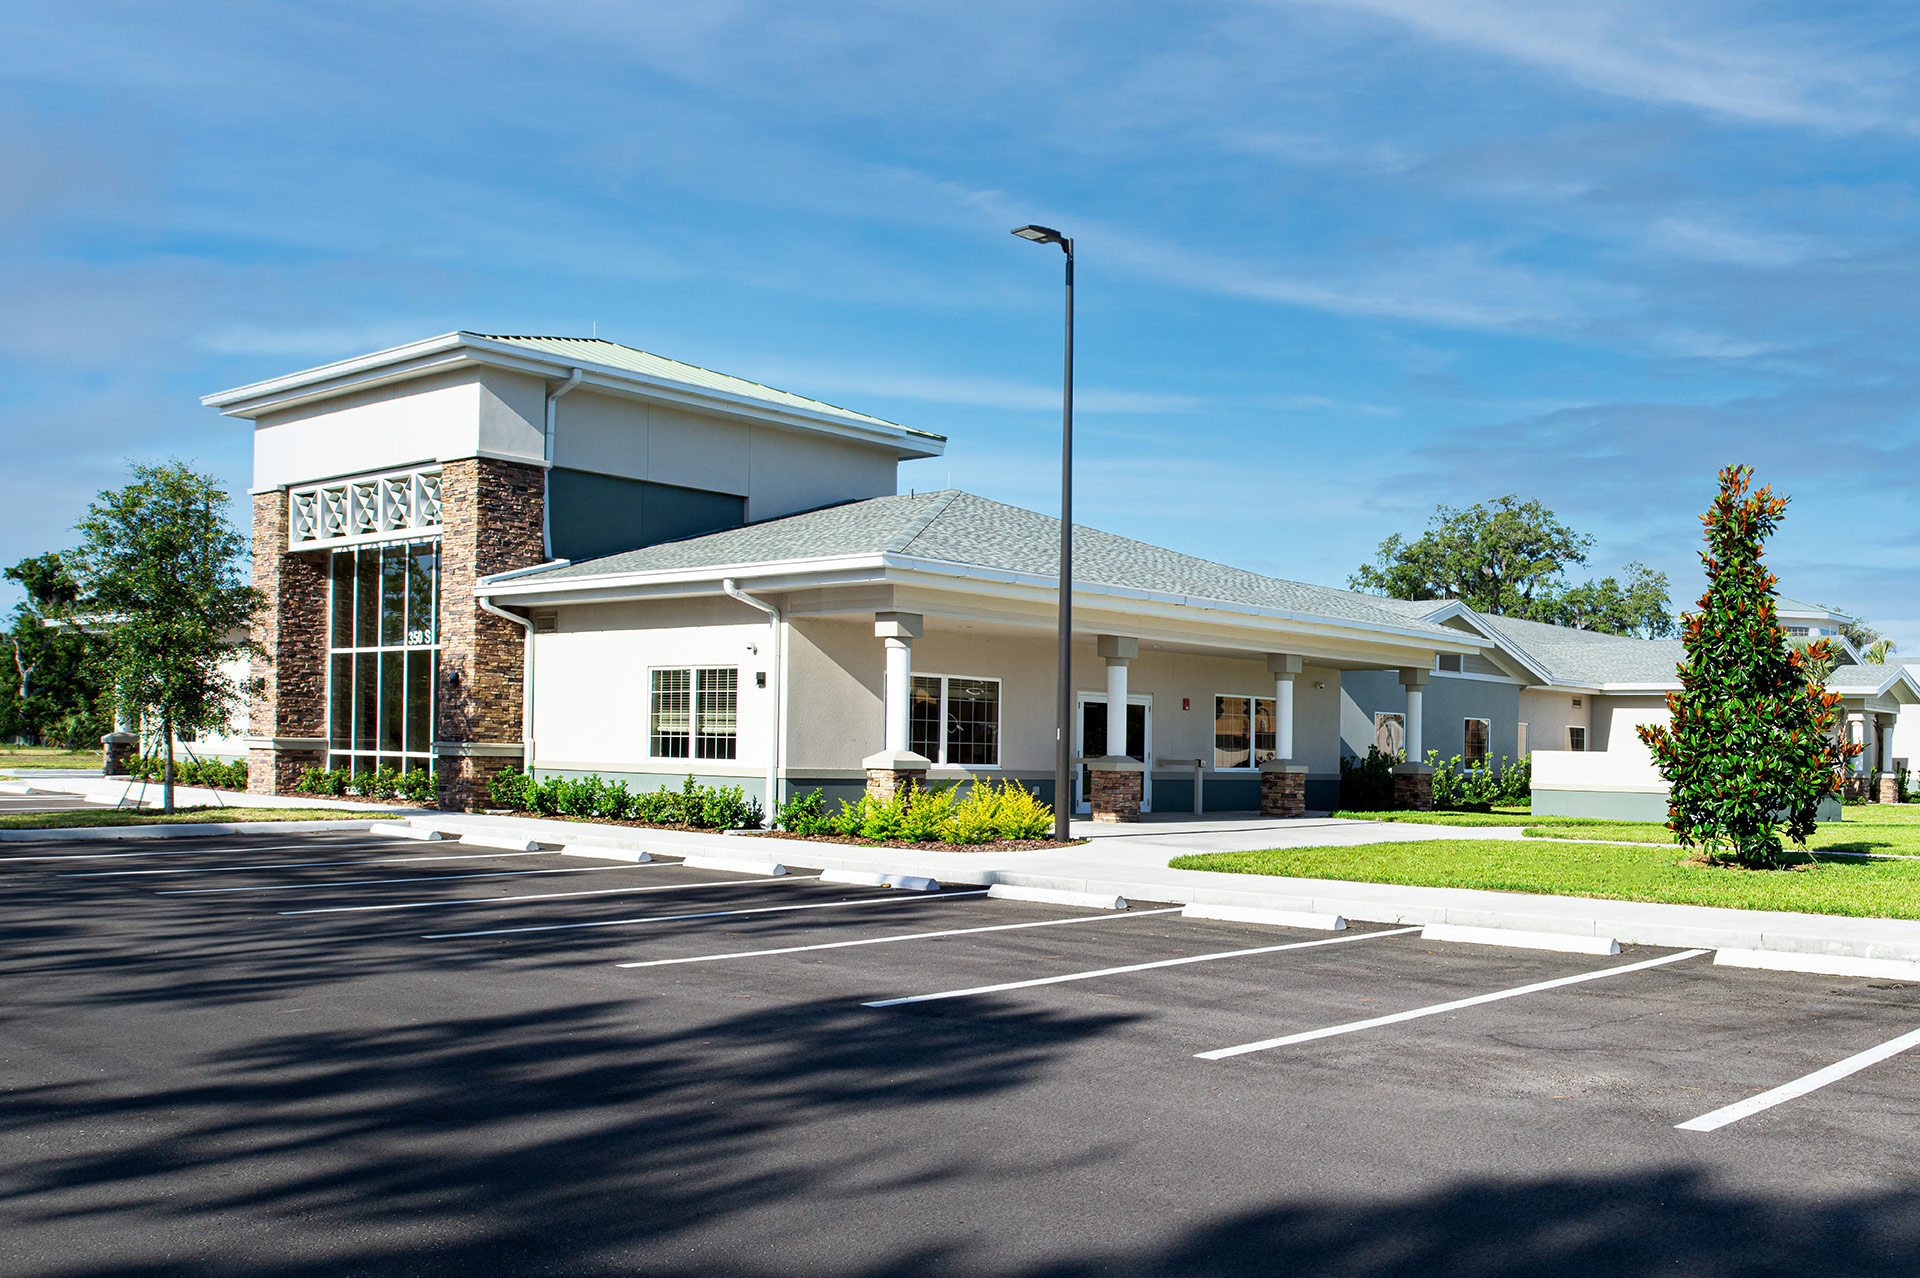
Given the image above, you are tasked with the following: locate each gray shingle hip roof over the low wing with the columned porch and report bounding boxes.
[516,489,1461,639]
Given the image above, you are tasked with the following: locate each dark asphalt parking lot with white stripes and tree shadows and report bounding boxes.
[0,833,1920,1276]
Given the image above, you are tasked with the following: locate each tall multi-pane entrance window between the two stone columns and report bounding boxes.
[326,541,440,771]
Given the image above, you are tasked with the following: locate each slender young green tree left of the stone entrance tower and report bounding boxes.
[73,461,259,812]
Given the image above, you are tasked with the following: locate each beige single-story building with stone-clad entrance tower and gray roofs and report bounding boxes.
[205,332,1920,819]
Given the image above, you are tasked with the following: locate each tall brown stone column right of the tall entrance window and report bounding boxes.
[434,457,543,810]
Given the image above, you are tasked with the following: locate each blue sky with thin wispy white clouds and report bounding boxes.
[0,0,1920,656]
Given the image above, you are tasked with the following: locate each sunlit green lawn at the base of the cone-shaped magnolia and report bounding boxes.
[1171,839,1920,919]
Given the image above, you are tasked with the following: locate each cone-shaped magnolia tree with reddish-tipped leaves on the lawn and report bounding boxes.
[1640,466,1860,867]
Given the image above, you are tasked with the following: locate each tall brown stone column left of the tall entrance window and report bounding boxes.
[246,487,326,794]
